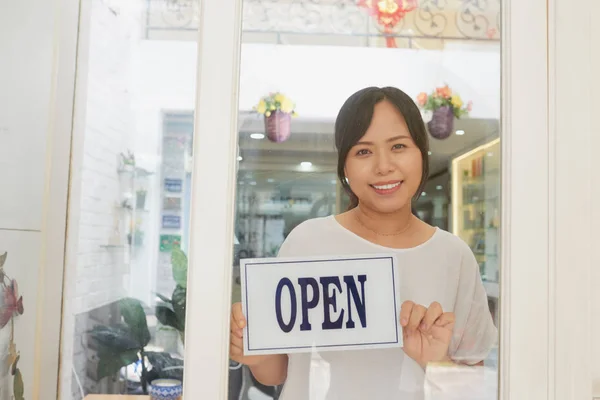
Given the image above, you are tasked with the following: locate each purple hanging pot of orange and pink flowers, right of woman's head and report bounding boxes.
[417,85,473,139]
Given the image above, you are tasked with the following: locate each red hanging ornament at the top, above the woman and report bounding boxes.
[358,0,417,48]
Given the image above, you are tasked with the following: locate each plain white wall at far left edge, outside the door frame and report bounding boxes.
[0,0,58,400]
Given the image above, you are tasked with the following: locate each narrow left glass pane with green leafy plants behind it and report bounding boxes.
[60,0,197,399]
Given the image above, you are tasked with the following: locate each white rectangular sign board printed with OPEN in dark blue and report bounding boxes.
[240,254,402,355]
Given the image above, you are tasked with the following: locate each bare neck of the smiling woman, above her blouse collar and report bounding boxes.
[353,204,414,236]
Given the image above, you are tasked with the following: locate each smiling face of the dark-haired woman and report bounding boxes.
[345,100,423,213]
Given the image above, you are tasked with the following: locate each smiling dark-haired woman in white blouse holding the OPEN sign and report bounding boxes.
[230,87,497,400]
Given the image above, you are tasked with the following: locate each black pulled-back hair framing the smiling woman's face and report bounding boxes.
[335,87,429,209]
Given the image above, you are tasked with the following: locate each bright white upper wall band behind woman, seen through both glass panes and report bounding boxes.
[135,41,500,127]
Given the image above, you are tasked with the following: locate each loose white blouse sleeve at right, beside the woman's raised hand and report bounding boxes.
[450,245,498,365]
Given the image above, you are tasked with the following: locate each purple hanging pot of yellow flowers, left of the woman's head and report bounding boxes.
[254,92,296,143]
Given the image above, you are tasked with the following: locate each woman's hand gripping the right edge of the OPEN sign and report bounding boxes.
[400,301,454,368]
